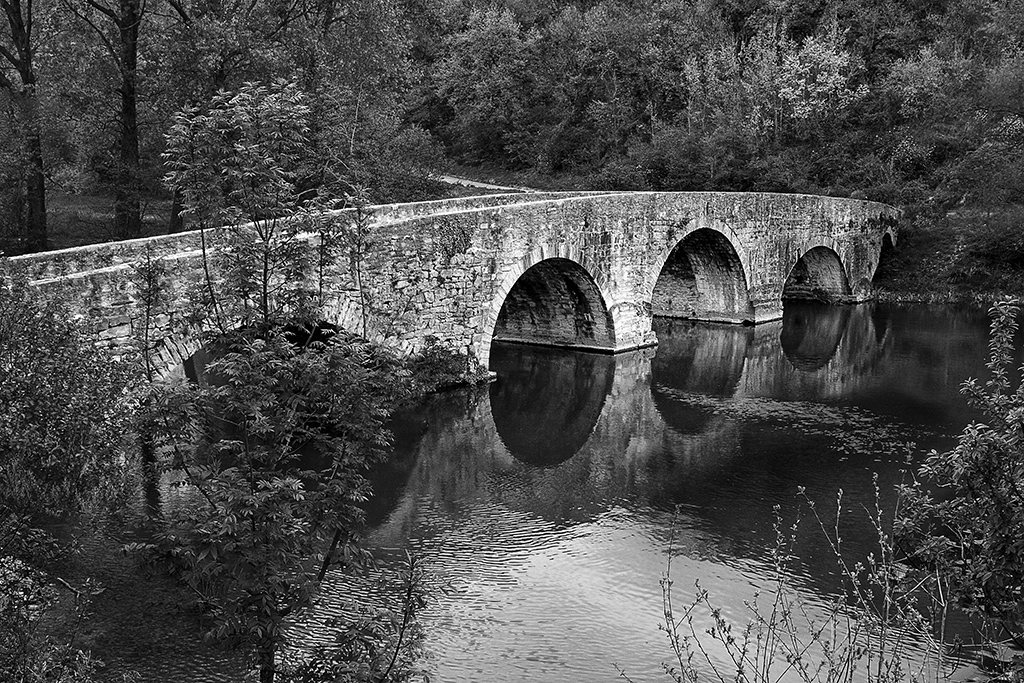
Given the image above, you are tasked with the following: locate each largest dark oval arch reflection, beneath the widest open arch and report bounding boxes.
[490,344,615,467]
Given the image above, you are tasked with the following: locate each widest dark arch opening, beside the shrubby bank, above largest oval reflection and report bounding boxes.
[493,258,615,351]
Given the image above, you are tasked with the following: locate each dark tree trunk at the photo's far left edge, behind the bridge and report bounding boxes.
[0,0,47,251]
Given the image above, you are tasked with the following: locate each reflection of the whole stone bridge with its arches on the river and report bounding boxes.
[378,306,890,517]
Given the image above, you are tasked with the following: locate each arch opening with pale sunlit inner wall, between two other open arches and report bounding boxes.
[651,228,754,323]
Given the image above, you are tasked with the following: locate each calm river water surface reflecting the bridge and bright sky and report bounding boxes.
[310,304,1007,682]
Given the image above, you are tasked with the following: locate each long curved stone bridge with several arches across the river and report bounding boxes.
[12,193,897,375]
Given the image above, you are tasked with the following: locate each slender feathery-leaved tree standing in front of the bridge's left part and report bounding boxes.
[143,82,428,682]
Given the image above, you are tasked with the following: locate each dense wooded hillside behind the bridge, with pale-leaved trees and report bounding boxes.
[414,0,1021,216]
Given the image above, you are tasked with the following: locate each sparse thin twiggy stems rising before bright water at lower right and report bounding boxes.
[620,481,945,683]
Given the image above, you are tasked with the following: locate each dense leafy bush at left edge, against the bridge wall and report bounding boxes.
[0,264,135,515]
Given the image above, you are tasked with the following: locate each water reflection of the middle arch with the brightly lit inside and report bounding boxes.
[651,318,754,434]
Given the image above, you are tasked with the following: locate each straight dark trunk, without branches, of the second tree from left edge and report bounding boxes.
[114,0,142,240]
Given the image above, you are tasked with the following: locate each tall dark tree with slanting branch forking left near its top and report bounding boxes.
[66,0,147,240]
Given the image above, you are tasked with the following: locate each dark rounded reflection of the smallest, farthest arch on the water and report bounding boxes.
[780,301,850,373]
